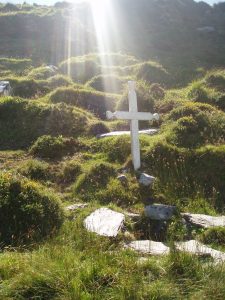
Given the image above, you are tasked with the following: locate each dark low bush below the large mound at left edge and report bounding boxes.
[30,135,81,159]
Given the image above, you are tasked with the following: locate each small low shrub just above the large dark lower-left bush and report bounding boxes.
[18,159,49,181]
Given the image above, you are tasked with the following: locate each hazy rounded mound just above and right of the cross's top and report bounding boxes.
[136,61,170,85]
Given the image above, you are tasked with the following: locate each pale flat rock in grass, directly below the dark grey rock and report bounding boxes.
[127,240,170,255]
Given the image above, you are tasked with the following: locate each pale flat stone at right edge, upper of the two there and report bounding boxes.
[182,213,225,228]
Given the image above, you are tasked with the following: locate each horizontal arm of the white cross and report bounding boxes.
[106,111,159,121]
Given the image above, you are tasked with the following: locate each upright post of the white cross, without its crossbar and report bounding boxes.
[128,81,141,170]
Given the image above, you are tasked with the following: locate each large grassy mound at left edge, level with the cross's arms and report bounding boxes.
[0,97,91,150]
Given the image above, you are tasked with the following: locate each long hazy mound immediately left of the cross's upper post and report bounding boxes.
[50,88,115,118]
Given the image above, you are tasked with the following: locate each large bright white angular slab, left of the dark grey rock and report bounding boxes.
[84,208,125,237]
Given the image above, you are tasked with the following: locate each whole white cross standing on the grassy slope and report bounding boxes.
[106,81,159,170]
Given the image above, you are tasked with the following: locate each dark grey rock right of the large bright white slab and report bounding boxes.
[145,204,176,221]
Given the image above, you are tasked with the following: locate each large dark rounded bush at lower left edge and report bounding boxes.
[0,173,63,245]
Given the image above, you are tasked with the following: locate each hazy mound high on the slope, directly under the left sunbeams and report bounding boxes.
[60,57,100,83]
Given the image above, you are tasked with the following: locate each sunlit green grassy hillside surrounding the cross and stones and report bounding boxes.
[0,0,225,300]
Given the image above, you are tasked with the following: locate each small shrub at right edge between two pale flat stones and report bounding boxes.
[199,227,225,246]
